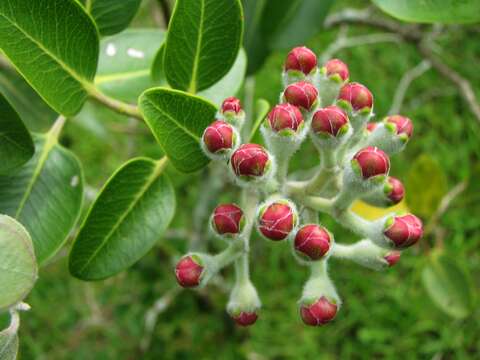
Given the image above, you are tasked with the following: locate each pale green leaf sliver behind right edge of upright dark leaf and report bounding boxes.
[198,49,247,107]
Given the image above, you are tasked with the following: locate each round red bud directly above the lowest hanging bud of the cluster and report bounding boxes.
[295,224,331,260]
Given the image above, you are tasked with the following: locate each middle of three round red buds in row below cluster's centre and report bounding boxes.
[258,202,296,241]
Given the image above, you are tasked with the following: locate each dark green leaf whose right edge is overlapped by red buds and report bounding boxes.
[139,88,217,172]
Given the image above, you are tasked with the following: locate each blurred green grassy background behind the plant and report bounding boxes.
[1,0,480,360]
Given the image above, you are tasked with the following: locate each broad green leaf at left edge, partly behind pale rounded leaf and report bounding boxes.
[0,132,83,264]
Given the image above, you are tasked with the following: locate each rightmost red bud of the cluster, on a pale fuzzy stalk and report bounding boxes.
[384,214,423,249]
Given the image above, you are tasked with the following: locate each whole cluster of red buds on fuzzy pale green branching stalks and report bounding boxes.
[176,47,423,326]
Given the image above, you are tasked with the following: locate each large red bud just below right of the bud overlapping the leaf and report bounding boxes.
[230,144,268,177]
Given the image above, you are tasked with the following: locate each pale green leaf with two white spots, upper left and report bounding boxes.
[95,29,165,103]
